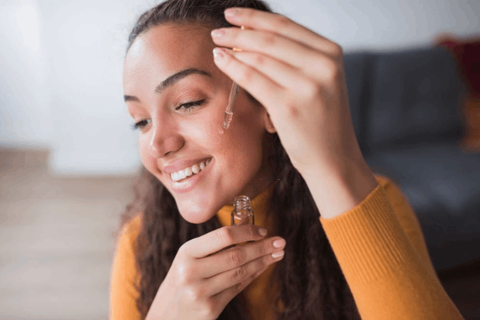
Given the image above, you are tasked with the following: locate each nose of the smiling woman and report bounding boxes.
[148,118,183,158]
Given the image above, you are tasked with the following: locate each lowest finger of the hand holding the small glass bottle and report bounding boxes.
[205,250,283,296]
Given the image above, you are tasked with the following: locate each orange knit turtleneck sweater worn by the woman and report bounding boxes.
[110,175,463,320]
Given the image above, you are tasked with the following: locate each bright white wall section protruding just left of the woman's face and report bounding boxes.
[37,0,156,175]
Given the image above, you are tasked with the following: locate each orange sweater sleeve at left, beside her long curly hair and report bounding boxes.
[109,217,140,320]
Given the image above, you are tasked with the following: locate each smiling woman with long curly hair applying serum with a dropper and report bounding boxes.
[110,0,462,320]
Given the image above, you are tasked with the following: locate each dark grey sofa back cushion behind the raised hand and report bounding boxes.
[366,48,464,150]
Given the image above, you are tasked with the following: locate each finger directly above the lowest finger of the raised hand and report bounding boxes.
[229,51,316,90]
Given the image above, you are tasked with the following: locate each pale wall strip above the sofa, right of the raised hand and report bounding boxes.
[272,0,480,51]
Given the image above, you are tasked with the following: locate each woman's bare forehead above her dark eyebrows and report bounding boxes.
[123,24,217,89]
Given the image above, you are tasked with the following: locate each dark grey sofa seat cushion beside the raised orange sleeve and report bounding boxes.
[365,143,480,270]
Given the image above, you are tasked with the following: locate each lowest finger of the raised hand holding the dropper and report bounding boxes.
[214,48,285,118]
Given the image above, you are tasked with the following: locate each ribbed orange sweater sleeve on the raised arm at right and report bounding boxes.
[320,175,463,320]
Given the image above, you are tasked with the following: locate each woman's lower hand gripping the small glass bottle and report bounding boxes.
[146,225,285,320]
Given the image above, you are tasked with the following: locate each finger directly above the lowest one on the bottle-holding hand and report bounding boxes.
[197,237,285,278]
